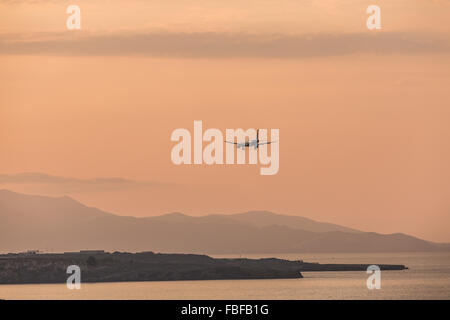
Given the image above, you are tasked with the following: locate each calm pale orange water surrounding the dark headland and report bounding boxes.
[0,253,450,299]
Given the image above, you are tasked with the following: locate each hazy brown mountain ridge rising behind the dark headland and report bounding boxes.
[0,190,449,254]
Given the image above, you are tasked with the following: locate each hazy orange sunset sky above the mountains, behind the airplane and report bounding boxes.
[0,0,450,242]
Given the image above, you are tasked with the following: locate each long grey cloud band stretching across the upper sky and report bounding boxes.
[0,31,450,59]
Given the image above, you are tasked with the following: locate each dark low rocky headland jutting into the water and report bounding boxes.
[0,252,406,284]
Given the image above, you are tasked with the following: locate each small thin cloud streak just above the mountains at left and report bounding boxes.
[0,172,169,193]
